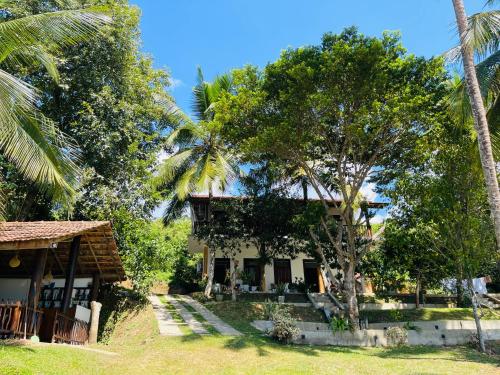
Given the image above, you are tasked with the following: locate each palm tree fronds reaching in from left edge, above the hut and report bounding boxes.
[0,0,110,216]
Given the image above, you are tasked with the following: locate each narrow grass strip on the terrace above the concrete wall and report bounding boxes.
[360,308,500,323]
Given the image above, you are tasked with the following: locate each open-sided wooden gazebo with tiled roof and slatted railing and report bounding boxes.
[0,221,125,343]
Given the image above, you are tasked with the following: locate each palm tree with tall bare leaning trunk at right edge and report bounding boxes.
[452,0,500,251]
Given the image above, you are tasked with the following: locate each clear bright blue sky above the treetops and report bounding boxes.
[131,0,484,113]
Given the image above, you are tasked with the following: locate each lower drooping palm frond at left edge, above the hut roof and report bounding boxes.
[0,70,78,201]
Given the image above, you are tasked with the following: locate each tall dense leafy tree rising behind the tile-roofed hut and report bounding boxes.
[0,0,176,287]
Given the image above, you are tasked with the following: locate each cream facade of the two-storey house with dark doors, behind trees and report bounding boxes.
[189,195,382,293]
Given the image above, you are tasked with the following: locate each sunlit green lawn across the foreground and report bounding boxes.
[0,307,500,375]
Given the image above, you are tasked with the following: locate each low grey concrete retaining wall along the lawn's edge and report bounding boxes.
[252,320,500,346]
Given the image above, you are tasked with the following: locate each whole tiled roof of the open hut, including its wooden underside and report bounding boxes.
[0,221,125,281]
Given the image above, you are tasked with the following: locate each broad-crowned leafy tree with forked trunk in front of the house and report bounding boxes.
[219,29,445,323]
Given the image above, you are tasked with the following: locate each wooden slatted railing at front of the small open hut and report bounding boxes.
[0,302,43,338]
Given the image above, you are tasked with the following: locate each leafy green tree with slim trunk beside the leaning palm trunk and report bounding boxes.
[382,117,498,352]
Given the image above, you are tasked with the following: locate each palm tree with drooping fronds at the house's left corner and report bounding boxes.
[157,68,238,297]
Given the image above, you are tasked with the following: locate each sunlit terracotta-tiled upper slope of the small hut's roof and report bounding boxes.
[0,221,110,243]
